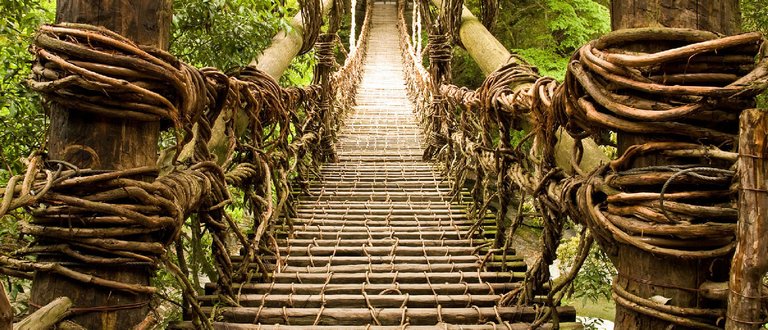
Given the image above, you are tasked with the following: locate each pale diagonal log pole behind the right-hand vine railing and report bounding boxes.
[432,0,609,172]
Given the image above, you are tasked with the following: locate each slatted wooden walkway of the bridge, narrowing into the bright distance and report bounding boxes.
[170,3,578,329]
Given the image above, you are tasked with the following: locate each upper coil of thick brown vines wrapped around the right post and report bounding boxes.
[562,28,768,146]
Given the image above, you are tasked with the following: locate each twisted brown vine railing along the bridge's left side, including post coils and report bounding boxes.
[0,0,372,327]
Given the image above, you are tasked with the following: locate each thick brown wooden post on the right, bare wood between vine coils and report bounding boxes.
[611,0,740,329]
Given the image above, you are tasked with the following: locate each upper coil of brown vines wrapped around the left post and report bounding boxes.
[27,23,207,128]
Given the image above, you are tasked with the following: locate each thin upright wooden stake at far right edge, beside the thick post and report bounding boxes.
[725,109,768,330]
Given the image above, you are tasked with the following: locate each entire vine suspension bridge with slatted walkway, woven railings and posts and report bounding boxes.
[0,0,768,330]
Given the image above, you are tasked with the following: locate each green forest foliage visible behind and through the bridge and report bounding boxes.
[0,0,768,324]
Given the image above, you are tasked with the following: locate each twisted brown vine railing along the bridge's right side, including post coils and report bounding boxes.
[398,1,768,329]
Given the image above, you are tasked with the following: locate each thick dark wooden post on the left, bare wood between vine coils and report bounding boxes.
[30,0,172,329]
